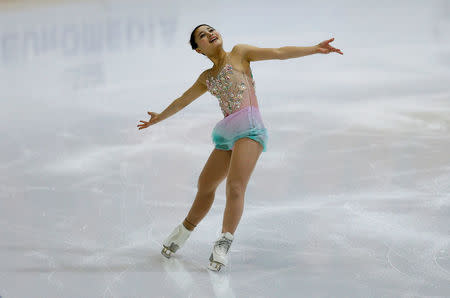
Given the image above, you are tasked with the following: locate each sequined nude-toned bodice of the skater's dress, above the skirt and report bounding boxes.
[206,55,258,117]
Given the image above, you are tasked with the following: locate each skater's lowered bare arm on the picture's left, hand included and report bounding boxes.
[137,70,208,129]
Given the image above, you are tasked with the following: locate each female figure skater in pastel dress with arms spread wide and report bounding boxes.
[138,24,343,271]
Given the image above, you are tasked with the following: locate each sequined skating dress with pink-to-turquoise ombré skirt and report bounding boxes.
[206,54,268,152]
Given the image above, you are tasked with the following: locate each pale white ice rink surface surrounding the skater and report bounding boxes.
[0,0,450,298]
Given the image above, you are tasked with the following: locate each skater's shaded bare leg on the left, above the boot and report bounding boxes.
[183,148,231,231]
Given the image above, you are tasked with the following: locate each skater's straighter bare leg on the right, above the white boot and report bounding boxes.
[222,138,263,234]
